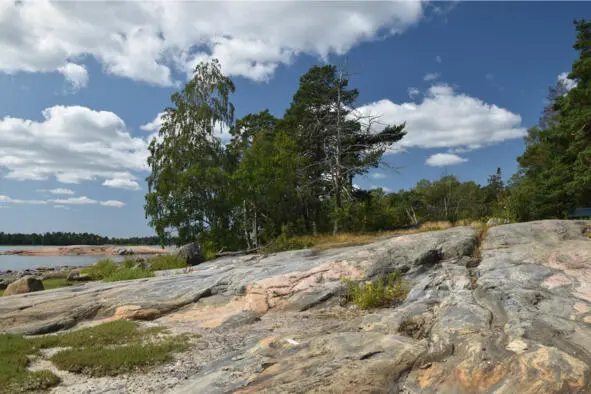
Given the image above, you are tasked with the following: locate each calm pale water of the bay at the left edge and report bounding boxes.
[0,245,123,271]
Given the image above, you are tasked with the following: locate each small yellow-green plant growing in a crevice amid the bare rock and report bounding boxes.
[342,272,410,309]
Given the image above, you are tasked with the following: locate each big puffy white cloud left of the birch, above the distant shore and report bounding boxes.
[0,106,148,187]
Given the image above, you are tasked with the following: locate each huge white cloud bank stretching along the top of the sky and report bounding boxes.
[0,0,424,86]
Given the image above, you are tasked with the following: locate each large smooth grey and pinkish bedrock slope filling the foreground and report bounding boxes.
[0,221,591,393]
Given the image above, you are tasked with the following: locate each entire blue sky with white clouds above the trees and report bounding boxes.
[0,0,591,237]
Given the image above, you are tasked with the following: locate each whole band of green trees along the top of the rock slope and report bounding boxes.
[145,20,591,249]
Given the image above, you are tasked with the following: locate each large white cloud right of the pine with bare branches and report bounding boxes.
[358,85,527,153]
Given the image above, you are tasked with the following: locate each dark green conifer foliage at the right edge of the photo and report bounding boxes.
[508,20,591,221]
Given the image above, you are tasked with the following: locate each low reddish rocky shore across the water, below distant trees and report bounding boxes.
[0,245,168,256]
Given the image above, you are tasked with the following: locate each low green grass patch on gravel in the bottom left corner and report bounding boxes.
[0,320,189,394]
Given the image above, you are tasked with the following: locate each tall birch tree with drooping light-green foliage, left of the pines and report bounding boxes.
[145,60,235,248]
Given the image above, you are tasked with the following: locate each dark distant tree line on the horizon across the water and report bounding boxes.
[0,232,160,246]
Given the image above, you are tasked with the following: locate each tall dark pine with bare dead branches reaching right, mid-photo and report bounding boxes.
[282,65,405,233]
